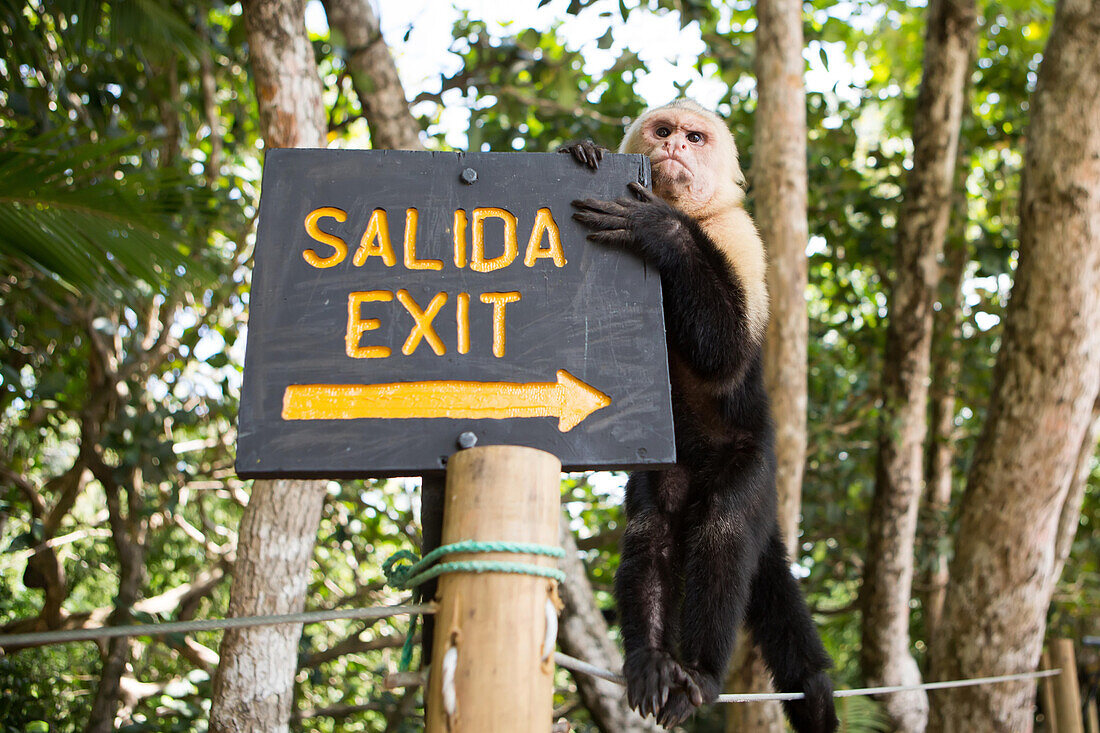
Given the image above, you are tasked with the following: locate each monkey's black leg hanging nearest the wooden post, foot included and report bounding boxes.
[615,469,693,715]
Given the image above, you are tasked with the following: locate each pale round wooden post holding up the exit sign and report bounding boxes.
[426,446,561,733]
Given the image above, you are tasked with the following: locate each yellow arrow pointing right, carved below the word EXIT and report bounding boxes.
[283,370,612,433]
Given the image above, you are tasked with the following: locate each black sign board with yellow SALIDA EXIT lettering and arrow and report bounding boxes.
[237,150,675,478]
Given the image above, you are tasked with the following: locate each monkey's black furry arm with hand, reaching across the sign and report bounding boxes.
[573,183,757,379]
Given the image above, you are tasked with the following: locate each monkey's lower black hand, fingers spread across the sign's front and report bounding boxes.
[573,182,693,269]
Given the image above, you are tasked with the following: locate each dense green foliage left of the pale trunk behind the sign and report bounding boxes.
[0,2,259,731]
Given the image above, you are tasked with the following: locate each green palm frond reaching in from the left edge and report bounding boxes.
[0,130,210,296]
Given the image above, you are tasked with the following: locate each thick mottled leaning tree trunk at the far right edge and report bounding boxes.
[932,0,1100,733]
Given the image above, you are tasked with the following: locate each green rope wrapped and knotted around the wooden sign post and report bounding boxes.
[382,539,565,671]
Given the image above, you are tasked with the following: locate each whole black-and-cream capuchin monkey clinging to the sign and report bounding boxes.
[561,100,837,733]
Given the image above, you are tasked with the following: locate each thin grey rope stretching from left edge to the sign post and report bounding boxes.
[0,603,436,647]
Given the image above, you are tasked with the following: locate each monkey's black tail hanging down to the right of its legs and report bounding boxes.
[746,528,837,733]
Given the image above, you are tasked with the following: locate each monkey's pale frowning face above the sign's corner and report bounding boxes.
[640,109,728,209]
